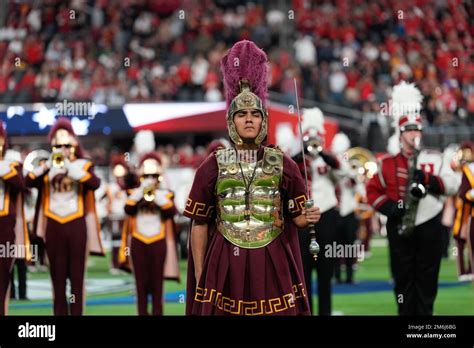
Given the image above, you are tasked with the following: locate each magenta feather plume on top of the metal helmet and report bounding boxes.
[221,40,268,106]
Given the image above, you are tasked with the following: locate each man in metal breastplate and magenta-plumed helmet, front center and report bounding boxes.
[184,40,319,315]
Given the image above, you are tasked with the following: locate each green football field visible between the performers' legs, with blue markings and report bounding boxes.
[9,239,474,315]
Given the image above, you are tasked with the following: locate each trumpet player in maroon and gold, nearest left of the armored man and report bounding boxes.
[119,152,179,315]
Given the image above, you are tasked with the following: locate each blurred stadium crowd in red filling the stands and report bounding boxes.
[0,0,474,125]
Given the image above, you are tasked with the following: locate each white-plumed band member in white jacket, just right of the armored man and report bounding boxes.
[293,108,341,315]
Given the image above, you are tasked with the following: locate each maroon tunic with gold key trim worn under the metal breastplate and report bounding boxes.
[184,147,310,315]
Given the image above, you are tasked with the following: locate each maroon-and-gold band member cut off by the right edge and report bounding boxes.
[453,141,474,281]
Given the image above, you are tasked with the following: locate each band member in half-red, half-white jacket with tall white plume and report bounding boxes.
[367,81,459,315]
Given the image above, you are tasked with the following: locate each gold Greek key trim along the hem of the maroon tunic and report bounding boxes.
[194,283,306,316]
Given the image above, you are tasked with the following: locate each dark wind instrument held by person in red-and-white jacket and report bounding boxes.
[398,138,427,236]
